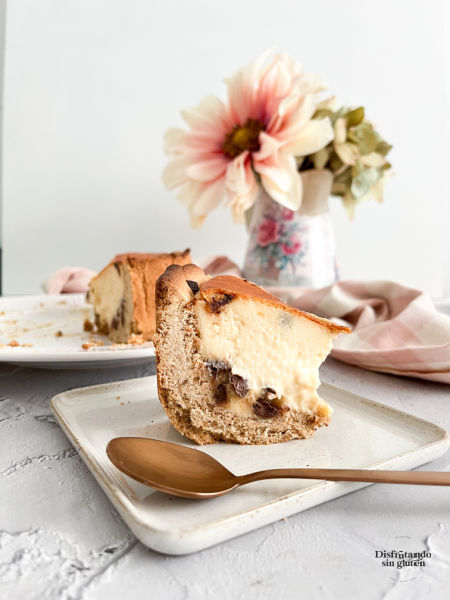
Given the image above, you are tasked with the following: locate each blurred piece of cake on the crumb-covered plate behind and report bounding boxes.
[87,250,191,343]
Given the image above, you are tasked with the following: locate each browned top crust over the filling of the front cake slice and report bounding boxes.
[200,275,351,335]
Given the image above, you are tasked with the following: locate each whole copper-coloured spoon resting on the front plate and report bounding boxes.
[106,437,450,498]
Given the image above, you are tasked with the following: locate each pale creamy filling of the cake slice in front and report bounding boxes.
[194,298,333,417]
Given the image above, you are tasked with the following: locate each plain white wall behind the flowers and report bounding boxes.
[2,0,450,296]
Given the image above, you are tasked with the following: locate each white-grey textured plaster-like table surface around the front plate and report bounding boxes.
[0,359,450,600]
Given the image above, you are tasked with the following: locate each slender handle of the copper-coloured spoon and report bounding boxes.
[238,469,450,485]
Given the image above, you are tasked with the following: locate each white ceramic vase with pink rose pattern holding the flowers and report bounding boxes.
[244,169,337,288]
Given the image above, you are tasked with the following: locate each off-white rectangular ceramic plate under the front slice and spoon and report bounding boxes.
[52,376,450,554]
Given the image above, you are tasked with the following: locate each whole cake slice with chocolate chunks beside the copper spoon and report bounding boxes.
[154,265,350,444]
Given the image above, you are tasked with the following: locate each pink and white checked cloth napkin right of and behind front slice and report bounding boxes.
[203,256,450,384]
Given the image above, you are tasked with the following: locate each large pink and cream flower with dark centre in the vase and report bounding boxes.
[163,53,333,226]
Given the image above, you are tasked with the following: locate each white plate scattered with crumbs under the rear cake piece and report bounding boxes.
[0,294,155,369]
